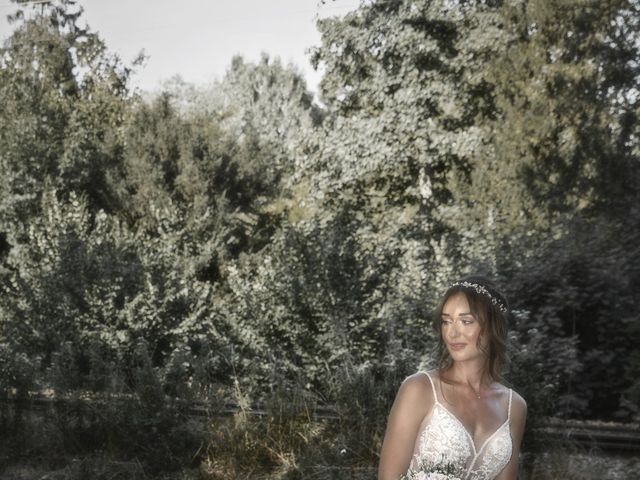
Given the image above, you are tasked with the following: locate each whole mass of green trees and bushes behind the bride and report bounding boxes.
[0,0,640,478]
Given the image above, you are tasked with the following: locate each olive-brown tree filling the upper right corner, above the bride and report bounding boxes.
[443,0,639,256]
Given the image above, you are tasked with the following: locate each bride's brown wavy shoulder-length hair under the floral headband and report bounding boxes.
[434,275,509,381]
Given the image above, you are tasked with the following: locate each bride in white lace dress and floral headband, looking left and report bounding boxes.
[378,276,527,480]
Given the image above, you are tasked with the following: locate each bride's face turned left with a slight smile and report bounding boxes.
[440,293,486,362]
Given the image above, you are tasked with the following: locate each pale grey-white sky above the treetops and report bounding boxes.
[0,0,360,92]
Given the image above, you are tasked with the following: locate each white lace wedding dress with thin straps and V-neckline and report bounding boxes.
[411,372,513,480]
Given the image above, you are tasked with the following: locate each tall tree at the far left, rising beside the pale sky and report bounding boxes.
[0,0,131,244]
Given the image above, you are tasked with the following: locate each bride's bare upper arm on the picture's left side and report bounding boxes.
[378,373,433,480]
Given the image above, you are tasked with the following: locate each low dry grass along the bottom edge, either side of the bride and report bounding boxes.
[0,402,640,480]
